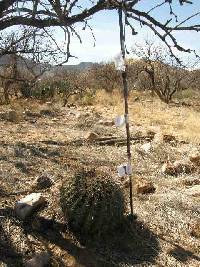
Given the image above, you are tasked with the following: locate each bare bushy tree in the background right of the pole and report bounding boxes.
[132,40,197,103]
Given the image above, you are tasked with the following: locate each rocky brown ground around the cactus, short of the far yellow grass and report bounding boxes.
[0,101,200,267]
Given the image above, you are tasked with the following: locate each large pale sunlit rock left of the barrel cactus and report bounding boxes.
[15,193,46,220]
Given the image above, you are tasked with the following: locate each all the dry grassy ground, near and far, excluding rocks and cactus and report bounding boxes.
[0,92,200,267]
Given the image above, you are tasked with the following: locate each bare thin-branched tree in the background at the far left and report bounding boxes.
[0,27,71,103]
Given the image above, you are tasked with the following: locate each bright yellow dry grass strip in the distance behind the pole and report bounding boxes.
[94,91,200,143]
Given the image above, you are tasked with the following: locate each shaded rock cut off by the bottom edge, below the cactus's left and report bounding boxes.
[25,252,50,267]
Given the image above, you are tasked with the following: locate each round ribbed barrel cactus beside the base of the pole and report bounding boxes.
[60,170,125,239]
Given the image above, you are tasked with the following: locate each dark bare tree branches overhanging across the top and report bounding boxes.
[0,0,200,60]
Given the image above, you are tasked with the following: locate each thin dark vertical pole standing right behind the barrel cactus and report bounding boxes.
[118,8,133,216]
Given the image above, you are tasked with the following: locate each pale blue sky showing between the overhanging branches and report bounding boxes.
[56,0,200,64]
